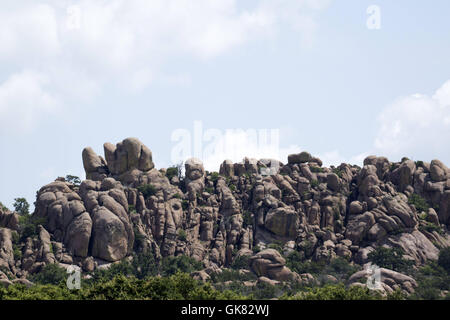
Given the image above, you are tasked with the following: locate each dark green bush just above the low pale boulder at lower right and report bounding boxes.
[367,247,414,272]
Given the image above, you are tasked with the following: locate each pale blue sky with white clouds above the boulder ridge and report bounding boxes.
[0,0,450,208]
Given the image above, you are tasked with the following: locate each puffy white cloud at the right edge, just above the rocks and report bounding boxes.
[375,81,450,162]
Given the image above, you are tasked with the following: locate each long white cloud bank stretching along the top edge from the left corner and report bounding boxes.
[0,0,329,90]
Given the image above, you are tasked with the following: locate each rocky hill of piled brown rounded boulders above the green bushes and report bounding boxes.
[0,138,450,292]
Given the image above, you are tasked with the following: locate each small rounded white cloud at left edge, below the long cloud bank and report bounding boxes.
[0,71,58,132]
